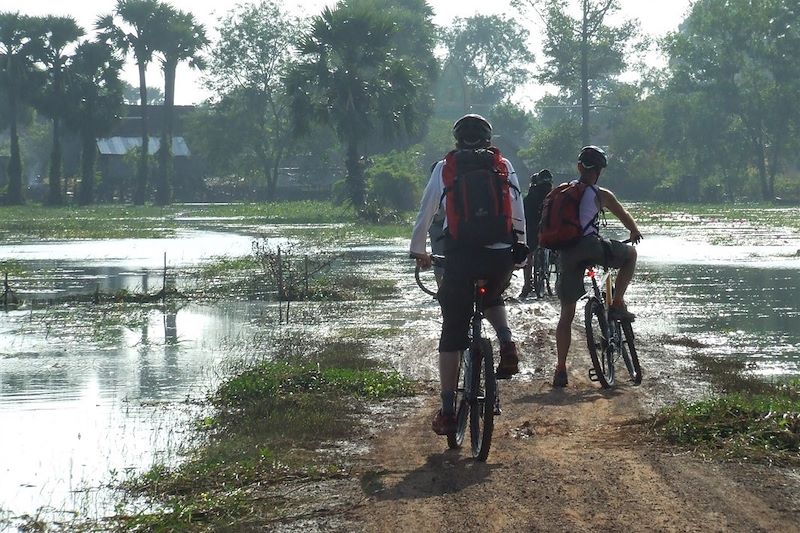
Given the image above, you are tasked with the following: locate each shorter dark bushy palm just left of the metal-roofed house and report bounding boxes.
[65,41,122,205]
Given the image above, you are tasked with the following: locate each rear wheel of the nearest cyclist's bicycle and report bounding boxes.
[469,339,497,461]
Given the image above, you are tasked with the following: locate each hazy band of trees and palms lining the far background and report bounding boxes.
[0,0,800,207]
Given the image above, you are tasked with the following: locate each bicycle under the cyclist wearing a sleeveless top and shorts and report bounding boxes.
[585,249,642,389]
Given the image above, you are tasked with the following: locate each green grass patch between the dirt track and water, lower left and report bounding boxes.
[107,341,414,531]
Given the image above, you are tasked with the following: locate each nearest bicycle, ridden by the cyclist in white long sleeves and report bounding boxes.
[414,255,501,461]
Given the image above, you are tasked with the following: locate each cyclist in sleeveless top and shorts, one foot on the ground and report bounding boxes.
[553,146,642,387]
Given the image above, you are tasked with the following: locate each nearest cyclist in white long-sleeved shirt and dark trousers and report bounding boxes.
[410,114,527,435]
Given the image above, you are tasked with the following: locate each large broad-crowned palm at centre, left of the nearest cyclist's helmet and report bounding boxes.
[287,2,421,212]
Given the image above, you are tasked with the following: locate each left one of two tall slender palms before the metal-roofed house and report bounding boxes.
[95,0,167,205]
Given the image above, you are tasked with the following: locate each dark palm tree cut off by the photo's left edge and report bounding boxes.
[0,12,41,205]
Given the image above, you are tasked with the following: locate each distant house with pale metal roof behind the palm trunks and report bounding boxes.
[97,105,204,200]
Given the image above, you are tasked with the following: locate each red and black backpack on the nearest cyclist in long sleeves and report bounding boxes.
[439,147,518,246]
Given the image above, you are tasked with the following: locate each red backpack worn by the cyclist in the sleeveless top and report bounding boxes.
[539,181,591,250]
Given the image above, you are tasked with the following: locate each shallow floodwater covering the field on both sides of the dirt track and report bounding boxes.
[0,207,800,528]
